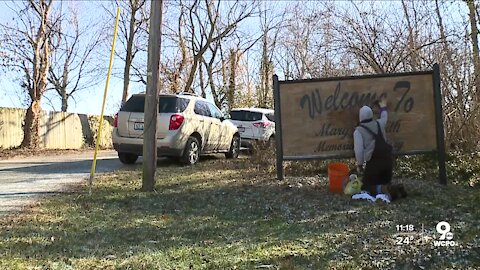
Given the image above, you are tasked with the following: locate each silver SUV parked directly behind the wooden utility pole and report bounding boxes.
[112,93,240,164]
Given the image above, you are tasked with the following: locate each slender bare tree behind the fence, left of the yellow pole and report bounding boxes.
[48,4,101,112]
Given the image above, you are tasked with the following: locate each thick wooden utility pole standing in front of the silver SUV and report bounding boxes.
[142,0,163,191]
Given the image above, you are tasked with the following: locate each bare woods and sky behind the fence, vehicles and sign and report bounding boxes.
[0,0,480,151]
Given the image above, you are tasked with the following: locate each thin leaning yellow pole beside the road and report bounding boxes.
[88,7,120,194]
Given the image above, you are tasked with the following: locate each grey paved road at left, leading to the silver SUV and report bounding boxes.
[0,151,131,217]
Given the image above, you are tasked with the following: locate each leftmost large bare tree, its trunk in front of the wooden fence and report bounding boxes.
[0,0,60,148]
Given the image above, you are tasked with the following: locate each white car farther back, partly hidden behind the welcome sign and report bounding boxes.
[230,108,275,147]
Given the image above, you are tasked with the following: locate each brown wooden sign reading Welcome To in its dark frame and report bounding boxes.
[274,65,445,185]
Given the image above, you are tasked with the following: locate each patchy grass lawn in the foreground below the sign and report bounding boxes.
[0,157,480,269]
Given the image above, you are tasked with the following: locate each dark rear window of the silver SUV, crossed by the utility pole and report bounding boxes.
[120,95,190,113]
